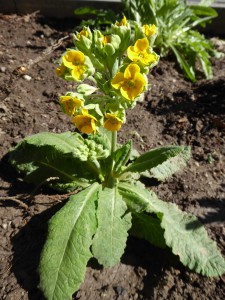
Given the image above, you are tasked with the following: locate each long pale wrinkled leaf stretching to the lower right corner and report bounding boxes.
[119,183,225,276]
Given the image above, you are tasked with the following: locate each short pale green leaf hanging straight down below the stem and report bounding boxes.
[92,187,131,267]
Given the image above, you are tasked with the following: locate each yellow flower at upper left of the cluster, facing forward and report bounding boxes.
[62,50,86,80]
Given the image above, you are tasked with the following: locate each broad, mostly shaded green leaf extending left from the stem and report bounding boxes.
[7,132,104,190]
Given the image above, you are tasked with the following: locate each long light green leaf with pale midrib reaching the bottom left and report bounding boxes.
[39,183,99,300]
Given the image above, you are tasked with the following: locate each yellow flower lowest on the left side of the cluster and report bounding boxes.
[72,109,97,134]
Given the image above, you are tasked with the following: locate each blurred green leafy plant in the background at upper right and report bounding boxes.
[122,0,221,82]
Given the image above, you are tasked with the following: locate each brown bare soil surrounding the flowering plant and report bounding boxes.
[0,15,225,300]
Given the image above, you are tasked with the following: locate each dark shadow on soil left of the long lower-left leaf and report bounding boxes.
[11,199,63,300]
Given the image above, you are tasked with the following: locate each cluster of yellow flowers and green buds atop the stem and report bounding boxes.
[56,16,159,134]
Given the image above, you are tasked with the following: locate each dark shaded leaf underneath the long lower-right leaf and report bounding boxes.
[129,213,166,248]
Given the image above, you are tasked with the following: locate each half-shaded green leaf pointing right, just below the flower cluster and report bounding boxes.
[122,146,190,180]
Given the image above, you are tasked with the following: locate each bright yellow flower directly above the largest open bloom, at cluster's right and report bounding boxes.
[127,38,157,66]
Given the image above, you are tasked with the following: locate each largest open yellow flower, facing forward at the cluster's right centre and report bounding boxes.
[111,63,146,100]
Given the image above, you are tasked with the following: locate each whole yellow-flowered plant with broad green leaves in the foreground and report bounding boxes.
[10,17,225,300]
